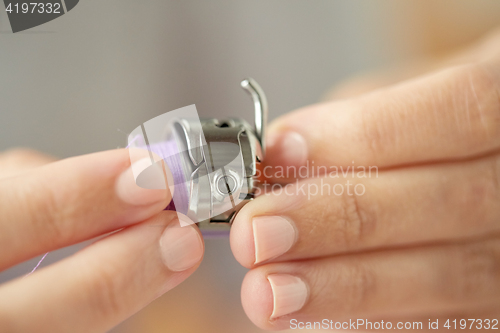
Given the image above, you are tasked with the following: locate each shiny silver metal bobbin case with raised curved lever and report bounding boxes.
[175,78,268,235]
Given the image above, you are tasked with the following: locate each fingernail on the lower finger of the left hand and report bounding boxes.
[160,225,203,272]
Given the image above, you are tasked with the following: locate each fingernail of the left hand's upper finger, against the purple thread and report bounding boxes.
[115,158,169,205]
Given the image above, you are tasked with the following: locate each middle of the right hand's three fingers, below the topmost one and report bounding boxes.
[230,155,500,267]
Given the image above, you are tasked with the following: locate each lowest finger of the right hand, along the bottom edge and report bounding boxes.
[241,238,500,329]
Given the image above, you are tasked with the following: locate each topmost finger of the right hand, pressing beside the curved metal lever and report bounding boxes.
[265,63,500,178]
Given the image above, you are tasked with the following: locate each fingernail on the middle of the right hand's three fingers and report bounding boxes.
[252,216,296,264]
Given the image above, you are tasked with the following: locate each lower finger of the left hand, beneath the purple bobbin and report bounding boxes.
[0,212,203,333]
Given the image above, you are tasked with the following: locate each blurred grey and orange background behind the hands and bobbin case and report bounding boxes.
[0,0,500,332]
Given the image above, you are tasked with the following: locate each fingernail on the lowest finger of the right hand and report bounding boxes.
[267,274,307,319]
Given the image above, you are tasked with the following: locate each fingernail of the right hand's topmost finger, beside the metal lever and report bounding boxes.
[266,131,308,166]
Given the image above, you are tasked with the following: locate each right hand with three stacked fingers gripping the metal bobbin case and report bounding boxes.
[231,29,500,329]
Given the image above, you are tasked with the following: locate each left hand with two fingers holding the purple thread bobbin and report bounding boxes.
[0,150,204,332]
